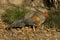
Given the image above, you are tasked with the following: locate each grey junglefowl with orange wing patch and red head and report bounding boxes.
[6,12,48,29]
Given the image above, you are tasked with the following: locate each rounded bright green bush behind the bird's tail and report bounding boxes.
[2,7,27,24]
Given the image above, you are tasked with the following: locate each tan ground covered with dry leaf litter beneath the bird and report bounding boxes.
[0,10,60,40]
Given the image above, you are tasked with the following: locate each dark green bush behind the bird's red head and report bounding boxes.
[44,11,60,28]
